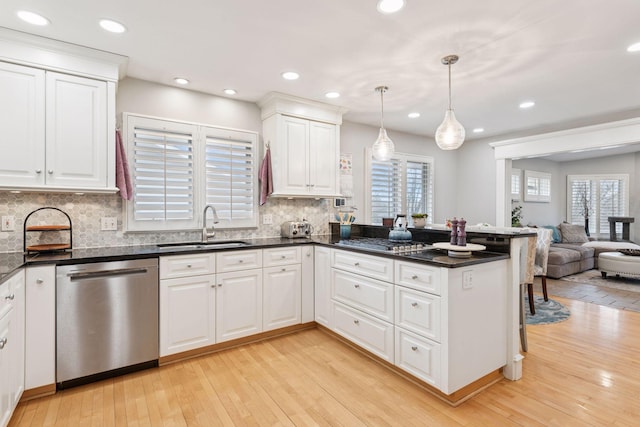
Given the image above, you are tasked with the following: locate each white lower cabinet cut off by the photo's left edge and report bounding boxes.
[0,271,25,426]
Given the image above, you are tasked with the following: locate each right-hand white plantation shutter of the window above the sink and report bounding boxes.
[205,128,257,226]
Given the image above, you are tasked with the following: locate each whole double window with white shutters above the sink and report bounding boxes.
[123,113,258,231]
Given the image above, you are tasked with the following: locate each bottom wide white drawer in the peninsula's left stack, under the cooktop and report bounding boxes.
[333,302,394,363]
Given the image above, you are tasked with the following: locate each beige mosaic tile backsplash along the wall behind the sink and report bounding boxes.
[0,192,333,253]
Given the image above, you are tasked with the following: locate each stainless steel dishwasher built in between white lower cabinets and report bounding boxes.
[56,258,158,388]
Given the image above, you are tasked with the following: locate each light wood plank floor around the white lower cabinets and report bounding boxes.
[10,298,640,426]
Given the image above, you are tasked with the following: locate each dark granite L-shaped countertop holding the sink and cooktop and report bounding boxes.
[0,230,510,281]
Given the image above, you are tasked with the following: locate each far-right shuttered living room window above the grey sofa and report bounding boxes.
[567,174,629,237]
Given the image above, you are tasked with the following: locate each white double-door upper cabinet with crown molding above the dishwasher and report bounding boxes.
[0,29,125,193]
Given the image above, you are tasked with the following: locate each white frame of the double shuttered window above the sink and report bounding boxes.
[122,113,260,232]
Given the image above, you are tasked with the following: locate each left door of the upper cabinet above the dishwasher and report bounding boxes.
[0,62,45,187]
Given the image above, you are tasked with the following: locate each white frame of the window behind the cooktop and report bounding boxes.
[364,147,436,225]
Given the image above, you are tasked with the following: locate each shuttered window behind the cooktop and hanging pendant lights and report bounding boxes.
[365,149,434,225]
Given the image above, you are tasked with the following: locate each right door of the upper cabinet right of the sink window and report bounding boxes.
[309,121,340,195]
